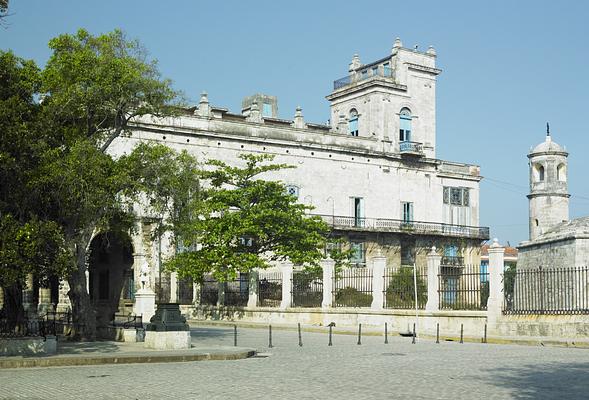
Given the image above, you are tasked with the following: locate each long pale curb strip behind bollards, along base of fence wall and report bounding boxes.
[187,320,589,349]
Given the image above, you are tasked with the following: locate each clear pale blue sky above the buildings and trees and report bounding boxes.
[0,0,589,245]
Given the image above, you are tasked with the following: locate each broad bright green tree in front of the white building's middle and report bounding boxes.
[167,154,328,281]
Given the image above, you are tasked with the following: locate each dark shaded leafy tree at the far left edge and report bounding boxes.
[0,51,71,321]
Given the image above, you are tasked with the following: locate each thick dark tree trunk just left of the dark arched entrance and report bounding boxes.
[68,244,96,341]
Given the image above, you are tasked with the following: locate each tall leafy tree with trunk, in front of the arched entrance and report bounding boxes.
[35,30,183,339]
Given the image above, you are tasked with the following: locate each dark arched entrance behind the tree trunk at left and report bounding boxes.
[88,232,135,327]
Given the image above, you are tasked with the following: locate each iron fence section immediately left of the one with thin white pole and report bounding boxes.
[332,268,372,307]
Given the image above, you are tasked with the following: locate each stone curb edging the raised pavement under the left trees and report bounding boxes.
[0,349,256,369]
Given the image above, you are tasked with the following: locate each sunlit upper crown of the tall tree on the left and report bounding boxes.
[42,29,179,151]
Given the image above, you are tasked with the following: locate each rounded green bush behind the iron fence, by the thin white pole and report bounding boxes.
[386,266,427,309]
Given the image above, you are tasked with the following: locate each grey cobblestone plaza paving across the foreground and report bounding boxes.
[0,327,589,400]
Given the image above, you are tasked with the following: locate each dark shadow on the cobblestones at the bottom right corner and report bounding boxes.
[483,360,589,399]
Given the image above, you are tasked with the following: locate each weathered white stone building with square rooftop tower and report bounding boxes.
[46,39,489,322]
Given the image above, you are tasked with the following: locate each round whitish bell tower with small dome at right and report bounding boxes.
[527,123,571,240]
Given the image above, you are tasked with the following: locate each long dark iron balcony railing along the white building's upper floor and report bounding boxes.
[317,214,489,240]
